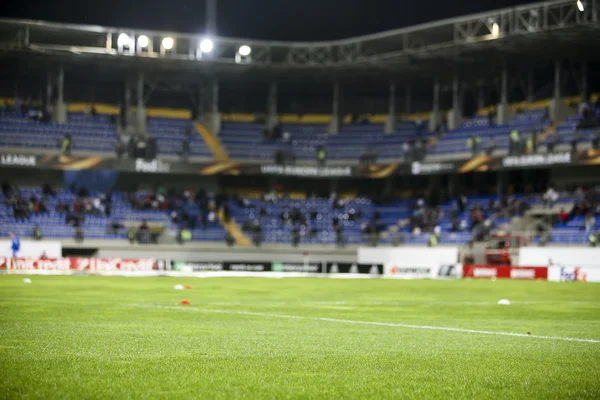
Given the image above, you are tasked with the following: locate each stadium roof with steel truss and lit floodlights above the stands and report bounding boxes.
[0,0,600,80]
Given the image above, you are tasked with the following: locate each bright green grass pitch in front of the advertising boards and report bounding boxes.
[0,276,600,399]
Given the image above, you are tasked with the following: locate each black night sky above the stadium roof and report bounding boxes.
[0,0,531,40]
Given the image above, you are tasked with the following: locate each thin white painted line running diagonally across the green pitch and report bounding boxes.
[130,304,600,343]
